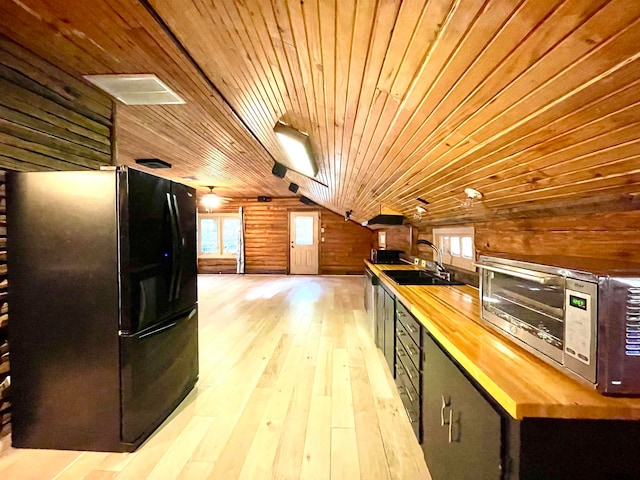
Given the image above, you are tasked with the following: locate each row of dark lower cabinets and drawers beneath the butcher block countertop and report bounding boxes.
[390,296,640,480]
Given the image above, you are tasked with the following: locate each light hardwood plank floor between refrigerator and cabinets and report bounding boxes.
[0,275,430,480]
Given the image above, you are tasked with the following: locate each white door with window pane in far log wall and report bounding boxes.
[289,211,318,275]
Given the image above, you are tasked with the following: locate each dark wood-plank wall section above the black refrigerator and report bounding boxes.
[0,35,113,171]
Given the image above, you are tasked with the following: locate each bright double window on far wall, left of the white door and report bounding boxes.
[198,214,240,257]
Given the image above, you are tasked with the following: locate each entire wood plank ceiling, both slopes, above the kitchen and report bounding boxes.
[0,0,640,223]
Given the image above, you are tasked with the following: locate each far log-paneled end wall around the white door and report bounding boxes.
[198,198,373,274]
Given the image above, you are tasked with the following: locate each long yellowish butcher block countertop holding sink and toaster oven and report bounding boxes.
[365,261,640,420]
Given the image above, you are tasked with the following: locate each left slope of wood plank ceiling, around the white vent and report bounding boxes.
[1,2,291,196]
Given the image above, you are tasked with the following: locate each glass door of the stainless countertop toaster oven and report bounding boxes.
[481,264,565,364]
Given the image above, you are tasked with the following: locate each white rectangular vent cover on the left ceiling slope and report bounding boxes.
[84,74,185,105]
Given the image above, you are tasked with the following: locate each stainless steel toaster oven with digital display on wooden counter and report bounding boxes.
[478,255,640,396]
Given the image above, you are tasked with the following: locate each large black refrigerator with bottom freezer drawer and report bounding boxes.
[7,167,198,451]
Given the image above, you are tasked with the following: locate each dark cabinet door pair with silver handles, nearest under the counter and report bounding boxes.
[422,333,501,480]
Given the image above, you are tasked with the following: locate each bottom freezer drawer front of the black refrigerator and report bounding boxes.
[120,308,198,449]
